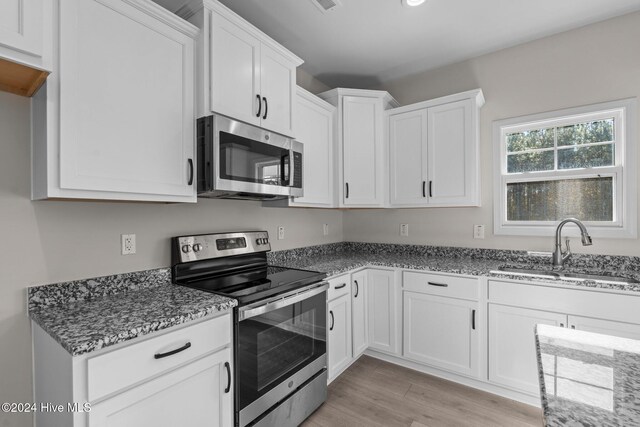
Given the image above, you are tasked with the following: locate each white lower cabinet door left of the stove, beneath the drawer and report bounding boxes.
[89,349,233,427]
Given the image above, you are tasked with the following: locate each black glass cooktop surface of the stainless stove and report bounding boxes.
[177,266,326,305]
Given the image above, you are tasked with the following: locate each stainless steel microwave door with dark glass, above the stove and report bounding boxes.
[212,116,295,196]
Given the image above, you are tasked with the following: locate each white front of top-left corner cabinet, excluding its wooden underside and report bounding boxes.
[0,0,53,71]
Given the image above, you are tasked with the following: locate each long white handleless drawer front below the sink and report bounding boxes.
[489,280,640,324]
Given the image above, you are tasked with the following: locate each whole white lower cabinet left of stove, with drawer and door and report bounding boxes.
[33,313,235,427]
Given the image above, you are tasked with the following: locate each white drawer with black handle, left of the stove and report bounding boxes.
[87,314,231,402]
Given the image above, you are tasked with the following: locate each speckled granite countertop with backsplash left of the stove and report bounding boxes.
[27,268,237,356]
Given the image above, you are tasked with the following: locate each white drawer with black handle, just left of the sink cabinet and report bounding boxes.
[402,271,479,301]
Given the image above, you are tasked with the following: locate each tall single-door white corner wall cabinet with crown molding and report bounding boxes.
[318,88,398,207]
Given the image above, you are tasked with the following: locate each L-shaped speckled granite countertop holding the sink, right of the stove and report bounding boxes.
[269,242,640,292]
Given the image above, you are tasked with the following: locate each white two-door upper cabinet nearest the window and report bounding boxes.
[385,89,484,207]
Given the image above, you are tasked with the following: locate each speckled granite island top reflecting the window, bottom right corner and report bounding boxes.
[536,325,640,427]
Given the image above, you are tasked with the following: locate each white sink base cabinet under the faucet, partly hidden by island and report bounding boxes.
[488,281,640,396]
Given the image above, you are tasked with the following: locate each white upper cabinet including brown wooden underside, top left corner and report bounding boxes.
[0,0,53,96]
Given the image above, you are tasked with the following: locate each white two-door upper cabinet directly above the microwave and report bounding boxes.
[177,0,303,137]
